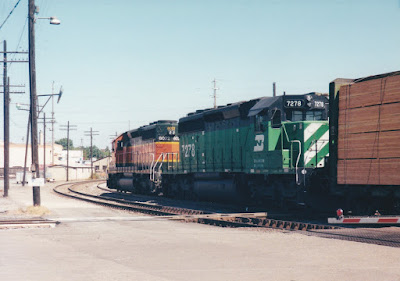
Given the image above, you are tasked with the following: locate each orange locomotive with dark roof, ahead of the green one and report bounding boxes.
[107,120,179,193]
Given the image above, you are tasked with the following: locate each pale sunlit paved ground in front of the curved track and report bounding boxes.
[0,182,400,281]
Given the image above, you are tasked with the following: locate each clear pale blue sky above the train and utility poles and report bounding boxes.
[0,0,400,148]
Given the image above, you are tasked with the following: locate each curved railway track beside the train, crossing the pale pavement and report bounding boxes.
[54,181,400,247]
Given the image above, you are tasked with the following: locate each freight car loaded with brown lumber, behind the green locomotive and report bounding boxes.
[329,71,400,213]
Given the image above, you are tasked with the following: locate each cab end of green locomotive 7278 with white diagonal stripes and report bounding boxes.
[248,93,329,197]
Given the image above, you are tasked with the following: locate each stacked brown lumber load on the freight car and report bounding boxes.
[337,72,400,185]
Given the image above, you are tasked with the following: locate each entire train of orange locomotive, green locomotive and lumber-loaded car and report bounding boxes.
[108,71,400,214]
